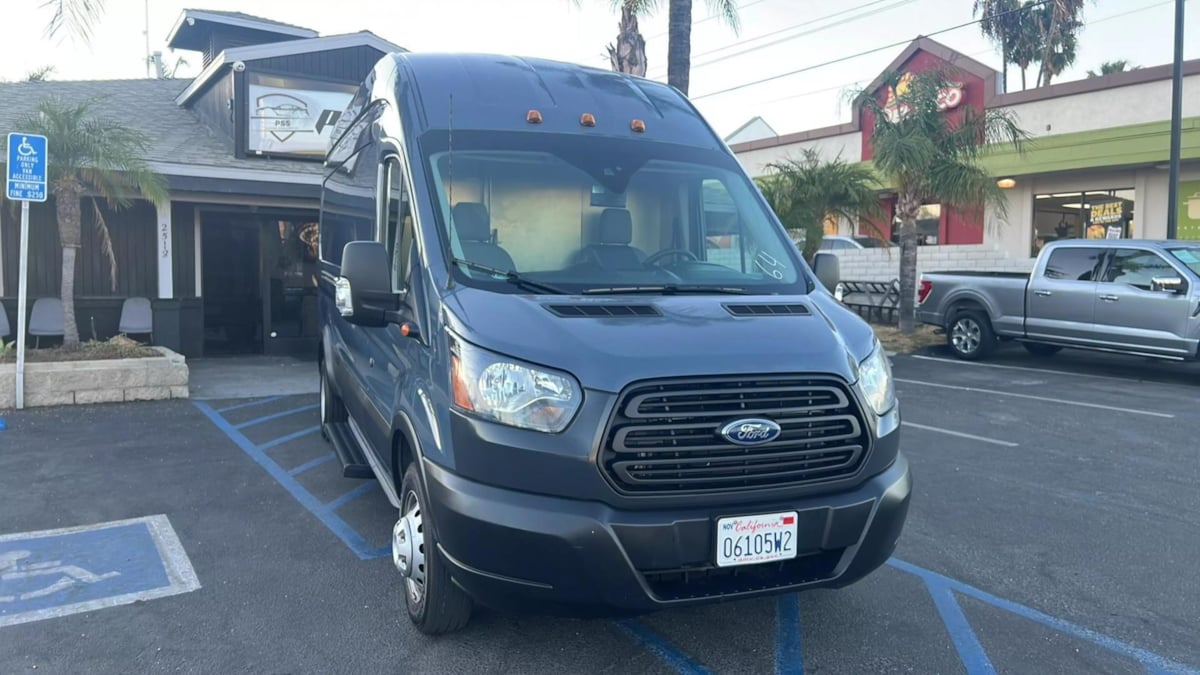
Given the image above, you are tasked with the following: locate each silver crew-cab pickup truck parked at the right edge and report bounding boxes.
[917,239,1200,360]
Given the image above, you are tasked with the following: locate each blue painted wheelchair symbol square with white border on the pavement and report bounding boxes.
[0,515,200,627]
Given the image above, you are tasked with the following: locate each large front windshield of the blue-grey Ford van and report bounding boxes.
[421,131,808,293]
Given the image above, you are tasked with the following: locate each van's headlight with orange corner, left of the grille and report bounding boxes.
[450,339,583,434]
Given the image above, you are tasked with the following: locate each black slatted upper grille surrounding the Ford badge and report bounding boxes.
[600,376,869,494]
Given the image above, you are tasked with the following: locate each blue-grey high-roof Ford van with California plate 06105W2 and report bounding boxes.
[319,53,912,633]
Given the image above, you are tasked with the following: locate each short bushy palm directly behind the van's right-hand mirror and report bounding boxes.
[757,148,882,262]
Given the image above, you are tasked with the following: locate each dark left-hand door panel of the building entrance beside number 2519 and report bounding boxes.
[200,213,263,356]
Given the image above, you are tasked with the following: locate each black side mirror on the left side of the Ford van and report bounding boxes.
[334,241,397,327]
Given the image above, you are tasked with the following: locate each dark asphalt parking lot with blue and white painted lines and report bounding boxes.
[0,351,1200,674]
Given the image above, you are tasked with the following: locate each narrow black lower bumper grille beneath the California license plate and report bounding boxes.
[642,549,844,601]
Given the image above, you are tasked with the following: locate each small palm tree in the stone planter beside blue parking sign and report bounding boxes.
[17,98,167,348]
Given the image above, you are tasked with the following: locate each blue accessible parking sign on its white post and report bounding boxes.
[5,132,47,410]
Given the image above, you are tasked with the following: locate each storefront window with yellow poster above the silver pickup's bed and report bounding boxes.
[1031,187,1134,256]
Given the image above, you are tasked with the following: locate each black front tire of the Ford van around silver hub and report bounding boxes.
[392,462,472,635]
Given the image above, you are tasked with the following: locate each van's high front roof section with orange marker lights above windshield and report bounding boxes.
[389,53,724,148]
